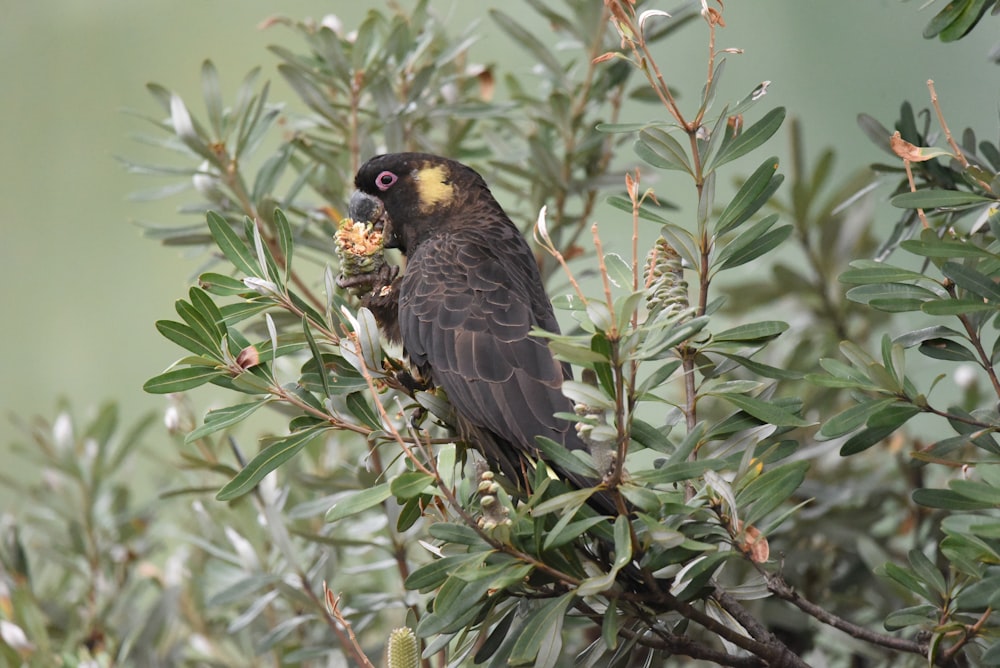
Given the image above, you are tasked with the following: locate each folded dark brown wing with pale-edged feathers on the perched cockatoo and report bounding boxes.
[399,231,578,454]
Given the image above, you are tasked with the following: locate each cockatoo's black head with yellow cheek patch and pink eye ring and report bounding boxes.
[350,153,499,253]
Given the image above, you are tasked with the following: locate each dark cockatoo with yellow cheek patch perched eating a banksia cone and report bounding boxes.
[350,153,615,513]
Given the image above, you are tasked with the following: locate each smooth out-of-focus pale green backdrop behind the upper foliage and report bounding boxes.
[0,0,998,460]
